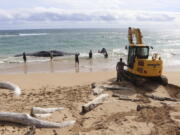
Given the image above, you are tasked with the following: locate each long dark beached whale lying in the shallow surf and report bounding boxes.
[15,50,75,57]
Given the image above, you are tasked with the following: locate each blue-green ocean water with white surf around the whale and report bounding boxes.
[0,29,180,73]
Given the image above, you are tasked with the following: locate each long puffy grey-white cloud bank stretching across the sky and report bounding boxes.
[0,7,177,22]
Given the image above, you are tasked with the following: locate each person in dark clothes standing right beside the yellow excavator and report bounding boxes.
[116,58,127,82]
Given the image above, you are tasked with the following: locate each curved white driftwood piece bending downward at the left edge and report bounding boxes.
[0,82,21,96]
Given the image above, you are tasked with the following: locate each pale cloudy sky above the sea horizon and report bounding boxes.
[0,0,180,29]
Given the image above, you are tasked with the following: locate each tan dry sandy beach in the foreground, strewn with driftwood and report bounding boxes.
[0,71,180,135]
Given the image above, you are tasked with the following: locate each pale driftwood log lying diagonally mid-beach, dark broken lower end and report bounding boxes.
[82,94,109,113]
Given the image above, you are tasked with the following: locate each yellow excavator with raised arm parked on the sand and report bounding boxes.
[125,27,168,85]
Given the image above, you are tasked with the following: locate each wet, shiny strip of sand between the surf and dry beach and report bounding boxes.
[0,58,180,75]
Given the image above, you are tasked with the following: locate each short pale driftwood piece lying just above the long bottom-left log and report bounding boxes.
[31,107,64,114]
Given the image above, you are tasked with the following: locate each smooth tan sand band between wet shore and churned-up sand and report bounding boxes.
[0,70,180,90]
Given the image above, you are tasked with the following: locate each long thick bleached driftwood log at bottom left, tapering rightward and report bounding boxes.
[0,112,75,128]
